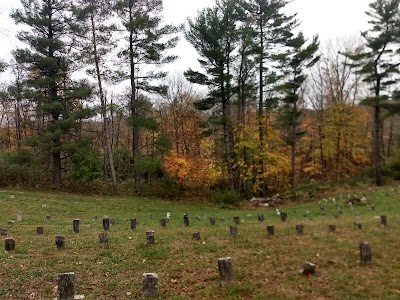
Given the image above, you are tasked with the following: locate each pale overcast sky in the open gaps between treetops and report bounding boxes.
[0,0,371,71]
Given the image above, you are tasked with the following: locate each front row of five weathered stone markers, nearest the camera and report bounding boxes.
[57,246,372,300]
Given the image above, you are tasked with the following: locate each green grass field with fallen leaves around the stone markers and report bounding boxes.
[0,188,400,300]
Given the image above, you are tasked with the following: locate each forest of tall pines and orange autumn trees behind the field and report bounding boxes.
[0,0,400,202]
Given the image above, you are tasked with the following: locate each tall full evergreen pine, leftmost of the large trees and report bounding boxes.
[11,0,91,187]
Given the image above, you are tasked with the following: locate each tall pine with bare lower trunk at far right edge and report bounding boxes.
[344,0,400,186]
